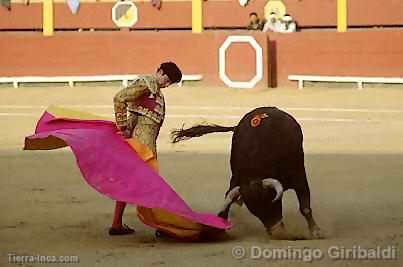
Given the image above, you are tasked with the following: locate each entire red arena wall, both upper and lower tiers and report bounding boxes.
[0,0,403,87]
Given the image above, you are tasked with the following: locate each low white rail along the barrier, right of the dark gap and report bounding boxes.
[288,75,403,89]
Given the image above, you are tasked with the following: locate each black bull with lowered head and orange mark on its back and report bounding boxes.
[172,107,323,239]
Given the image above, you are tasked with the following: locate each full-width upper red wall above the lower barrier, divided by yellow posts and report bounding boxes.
[0,0,403,29]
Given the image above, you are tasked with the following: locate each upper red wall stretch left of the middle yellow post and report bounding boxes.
[0,2,192,29]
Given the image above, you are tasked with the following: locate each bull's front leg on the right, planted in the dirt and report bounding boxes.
[295,171,324,239]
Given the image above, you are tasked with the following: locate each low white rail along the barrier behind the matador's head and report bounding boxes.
[0,74,203,88]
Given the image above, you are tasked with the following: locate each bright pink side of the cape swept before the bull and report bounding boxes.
[24,111,231,232]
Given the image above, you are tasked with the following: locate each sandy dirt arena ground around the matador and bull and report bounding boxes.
[0,84,403,266]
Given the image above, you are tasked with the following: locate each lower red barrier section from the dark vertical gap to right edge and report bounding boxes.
[269,30,403,86]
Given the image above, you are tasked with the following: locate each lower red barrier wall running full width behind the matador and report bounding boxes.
[0,30,403,87]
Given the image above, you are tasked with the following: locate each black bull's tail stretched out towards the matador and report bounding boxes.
[171,124,235,143]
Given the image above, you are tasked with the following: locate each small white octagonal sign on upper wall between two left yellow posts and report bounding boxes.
[112,1,138,28]
